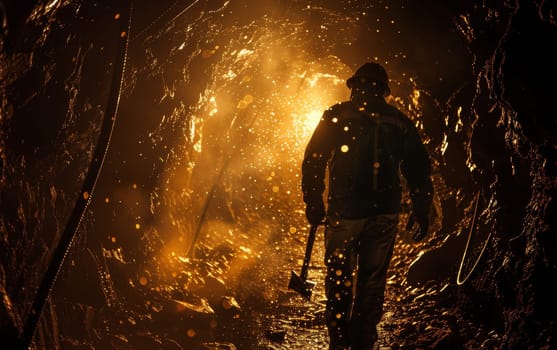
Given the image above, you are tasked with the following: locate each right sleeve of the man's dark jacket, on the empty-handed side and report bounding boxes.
[401,123,433,218]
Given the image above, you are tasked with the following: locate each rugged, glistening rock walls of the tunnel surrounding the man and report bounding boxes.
[0,0,557,349]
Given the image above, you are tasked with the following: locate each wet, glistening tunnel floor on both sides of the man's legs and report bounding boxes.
[50,227,494,350]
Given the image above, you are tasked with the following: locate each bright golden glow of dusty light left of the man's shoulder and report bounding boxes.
[151,21,352,276]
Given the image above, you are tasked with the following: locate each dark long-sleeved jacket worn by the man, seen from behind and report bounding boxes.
[302,98,433,218]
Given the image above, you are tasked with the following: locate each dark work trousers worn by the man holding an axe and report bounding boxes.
[325,214,398,350]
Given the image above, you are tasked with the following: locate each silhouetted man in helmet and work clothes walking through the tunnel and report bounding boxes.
[302,63,433,350]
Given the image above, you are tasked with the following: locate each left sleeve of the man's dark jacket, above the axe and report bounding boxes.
[302,110,334,204]
